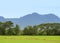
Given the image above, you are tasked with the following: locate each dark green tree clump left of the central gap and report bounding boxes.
[0,21,20,35]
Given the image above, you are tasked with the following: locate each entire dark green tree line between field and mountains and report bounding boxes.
[0,21,60,35]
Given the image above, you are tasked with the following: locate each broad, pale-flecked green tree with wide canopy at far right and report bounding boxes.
[38,23,60,35]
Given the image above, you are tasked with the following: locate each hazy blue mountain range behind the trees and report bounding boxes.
[0,13,60,28]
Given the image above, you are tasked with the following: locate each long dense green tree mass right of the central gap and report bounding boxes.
[23,23,60,35]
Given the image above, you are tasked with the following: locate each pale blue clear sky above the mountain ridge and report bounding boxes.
[0,0,60,18]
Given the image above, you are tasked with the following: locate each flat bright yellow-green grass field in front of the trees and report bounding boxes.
[0,36,60,43]
